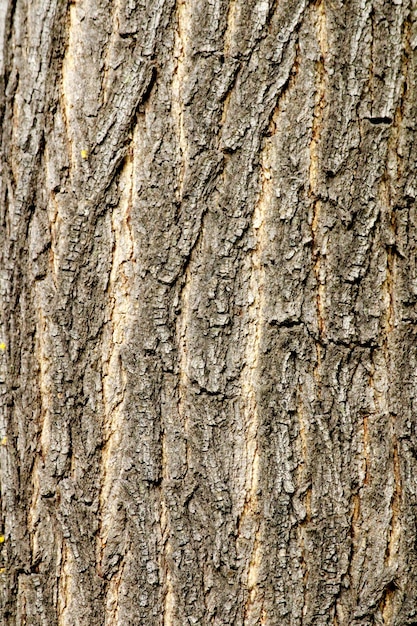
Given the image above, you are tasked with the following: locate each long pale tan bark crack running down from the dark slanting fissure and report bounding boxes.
[97,151,137,624]
